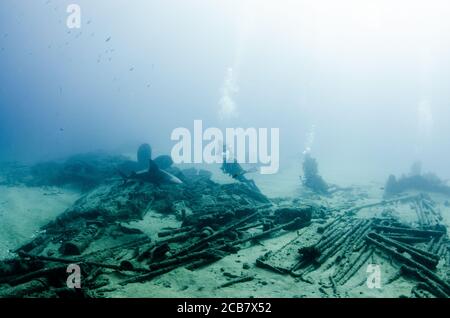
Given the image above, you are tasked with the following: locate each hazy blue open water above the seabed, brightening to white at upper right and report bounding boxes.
[0,0,450,184]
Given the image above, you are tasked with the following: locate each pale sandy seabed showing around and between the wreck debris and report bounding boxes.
[0,164,450,298]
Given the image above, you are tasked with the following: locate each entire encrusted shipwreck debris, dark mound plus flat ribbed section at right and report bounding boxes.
[0,152,450,298]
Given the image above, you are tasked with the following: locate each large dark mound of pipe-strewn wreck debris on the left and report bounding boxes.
[0,169,314,297]
